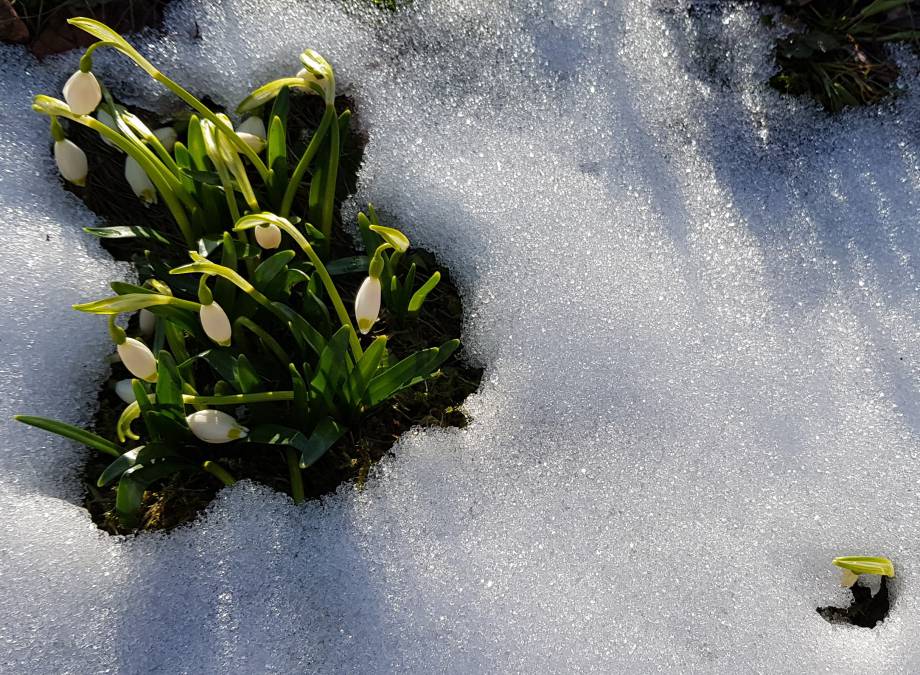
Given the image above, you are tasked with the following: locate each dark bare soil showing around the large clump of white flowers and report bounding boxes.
[57,90,482,534]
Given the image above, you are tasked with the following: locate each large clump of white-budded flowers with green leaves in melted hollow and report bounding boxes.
[17,18,459,527]
